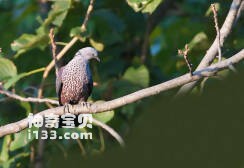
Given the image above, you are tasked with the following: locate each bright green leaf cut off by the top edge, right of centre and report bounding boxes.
[127,0,163,14]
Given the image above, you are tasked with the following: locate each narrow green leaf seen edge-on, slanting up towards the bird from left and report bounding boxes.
[4,68,45,90]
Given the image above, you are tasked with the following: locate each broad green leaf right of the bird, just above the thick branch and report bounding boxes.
[122,65,149,87]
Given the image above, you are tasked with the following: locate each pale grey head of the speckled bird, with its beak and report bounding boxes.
[75,47,100,62]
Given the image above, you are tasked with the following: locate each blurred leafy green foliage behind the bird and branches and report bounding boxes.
[0,0,244,167]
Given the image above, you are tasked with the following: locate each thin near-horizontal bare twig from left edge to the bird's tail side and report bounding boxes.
[0,90,59,105]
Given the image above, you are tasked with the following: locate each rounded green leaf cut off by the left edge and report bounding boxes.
[0,57,17,81]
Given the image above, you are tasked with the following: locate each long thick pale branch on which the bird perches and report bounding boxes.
[0,49,244,137]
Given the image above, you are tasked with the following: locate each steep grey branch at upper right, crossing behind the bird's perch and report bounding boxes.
[176,0,242,96]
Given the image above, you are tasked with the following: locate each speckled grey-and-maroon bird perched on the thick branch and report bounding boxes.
[56,47,100,106]
